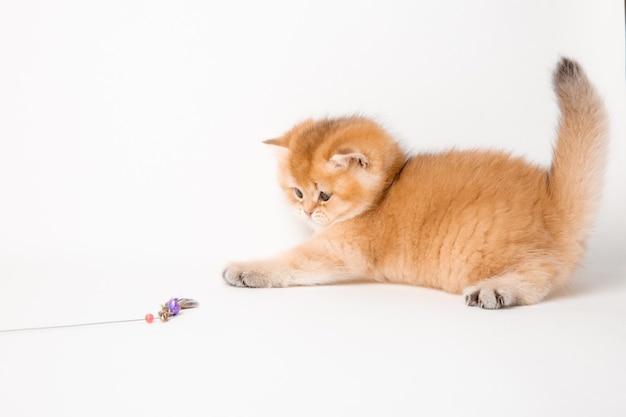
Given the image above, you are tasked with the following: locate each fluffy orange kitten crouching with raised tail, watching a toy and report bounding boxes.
[223,59,608,309]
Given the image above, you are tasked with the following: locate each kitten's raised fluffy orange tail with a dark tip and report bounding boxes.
[548,58,608,252]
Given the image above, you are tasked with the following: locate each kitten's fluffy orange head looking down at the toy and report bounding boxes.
[265,117,406,230]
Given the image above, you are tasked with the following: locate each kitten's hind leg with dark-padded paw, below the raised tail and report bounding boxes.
[463,270,555,310]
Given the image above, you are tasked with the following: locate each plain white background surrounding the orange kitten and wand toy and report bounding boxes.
[0,0,626,416]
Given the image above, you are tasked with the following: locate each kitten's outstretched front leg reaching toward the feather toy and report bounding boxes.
[222,238,365,287]
